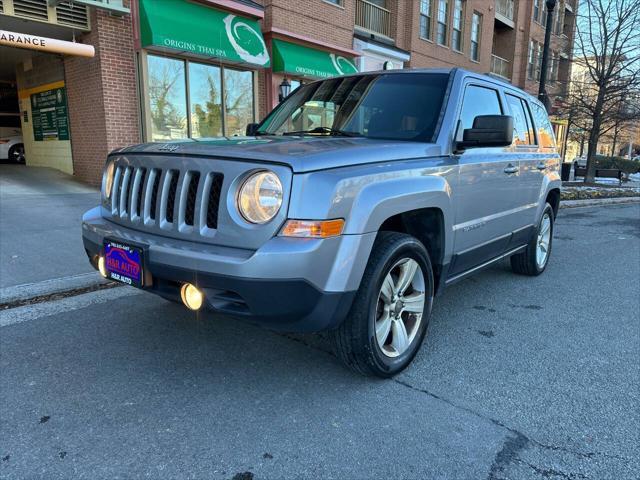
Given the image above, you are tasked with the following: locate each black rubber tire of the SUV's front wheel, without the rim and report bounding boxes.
[329,232,434,378]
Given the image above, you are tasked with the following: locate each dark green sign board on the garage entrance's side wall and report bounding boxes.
[31,87,69,142]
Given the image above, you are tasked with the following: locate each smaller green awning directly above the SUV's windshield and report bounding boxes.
[272,39,358,78]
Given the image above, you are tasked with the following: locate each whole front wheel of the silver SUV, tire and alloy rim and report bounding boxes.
[330,232,433,378]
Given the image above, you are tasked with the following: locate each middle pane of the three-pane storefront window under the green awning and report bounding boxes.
[189,63,222,138]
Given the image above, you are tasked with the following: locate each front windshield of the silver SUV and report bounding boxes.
[258,73,449,142]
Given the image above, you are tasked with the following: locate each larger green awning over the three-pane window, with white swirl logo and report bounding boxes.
[140,0,269,67]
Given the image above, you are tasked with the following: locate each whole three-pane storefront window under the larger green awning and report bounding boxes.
[147,55,255,142]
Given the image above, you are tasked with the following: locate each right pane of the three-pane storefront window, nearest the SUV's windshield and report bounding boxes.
[224,69,253,136]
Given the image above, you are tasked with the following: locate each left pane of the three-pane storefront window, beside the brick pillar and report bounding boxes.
[149,56,187,142]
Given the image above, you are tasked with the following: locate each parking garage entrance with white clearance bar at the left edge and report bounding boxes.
[0,15,93,174]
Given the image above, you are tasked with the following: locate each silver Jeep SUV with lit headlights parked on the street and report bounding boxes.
[83,69,560,377]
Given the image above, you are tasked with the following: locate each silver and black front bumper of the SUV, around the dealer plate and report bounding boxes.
[82,207,375,332]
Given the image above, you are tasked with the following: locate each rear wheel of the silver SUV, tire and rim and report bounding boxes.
[511,203,554,276]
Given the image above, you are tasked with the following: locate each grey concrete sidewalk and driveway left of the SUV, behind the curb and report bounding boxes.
[0,165,100,291]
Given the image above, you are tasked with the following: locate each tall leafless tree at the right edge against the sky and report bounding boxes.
[571,0,640,182]
